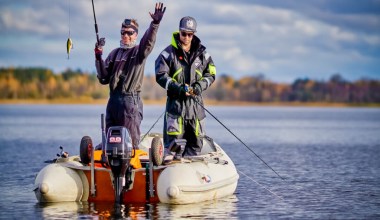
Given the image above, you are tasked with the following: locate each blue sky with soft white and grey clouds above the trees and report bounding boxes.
[0,0,380,83]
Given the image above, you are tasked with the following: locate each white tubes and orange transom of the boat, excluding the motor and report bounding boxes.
[34,137,239,204]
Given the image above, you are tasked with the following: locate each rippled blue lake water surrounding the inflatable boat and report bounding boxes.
[0,105,380,219]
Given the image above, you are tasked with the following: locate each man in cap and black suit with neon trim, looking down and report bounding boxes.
[155,16,216,156]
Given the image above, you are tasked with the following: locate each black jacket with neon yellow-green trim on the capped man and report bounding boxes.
[155,32,216,120]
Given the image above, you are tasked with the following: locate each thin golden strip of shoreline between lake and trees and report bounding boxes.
[0,99,380,108]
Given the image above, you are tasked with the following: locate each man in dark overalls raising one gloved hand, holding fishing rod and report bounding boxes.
[95,3,166,149]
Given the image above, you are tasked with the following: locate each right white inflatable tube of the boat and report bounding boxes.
[157,162,239,204]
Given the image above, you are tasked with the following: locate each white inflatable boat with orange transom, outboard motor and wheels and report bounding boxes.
[34,124,239,204]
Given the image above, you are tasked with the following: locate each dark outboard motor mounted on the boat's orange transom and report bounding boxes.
[106,126,133,203]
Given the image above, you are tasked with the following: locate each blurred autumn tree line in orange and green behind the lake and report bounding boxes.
[0,67,380,104]
